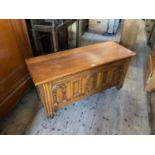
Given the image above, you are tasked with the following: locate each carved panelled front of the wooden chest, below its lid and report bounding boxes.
[38,60,127,114]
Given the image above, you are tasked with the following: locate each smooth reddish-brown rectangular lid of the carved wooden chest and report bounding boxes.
[26,42,135,85]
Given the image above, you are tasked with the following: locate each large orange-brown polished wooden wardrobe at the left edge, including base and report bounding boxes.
[0,19,32,118]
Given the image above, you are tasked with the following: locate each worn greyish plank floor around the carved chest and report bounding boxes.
[0,20,150,135]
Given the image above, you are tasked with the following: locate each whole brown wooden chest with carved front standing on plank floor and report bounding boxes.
[26,42,135,116]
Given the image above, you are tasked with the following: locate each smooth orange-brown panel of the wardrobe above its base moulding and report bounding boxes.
[0,20,32,101]
